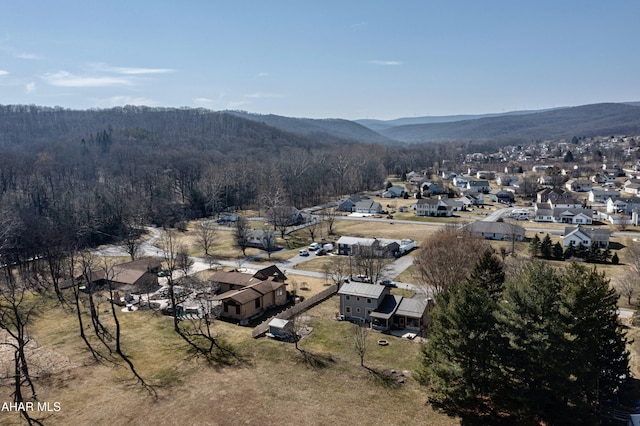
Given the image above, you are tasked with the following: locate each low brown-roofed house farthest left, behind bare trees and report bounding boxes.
[76,258,161,293]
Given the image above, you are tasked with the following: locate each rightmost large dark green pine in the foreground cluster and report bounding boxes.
[561,264,629,414]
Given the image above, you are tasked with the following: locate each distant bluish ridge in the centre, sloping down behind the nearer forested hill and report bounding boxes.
[226,111,394,144]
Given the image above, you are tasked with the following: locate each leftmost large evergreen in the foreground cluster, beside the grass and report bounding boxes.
[419,280,497,418]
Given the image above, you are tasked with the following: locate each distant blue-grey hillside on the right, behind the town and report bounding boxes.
[380,103,640,142]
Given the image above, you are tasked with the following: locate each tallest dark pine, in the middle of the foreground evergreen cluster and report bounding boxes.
[493,262,571,424]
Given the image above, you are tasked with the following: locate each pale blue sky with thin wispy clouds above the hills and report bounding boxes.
[0,0,640,120]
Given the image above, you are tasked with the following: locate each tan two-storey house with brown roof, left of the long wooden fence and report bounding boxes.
[211,265,287,321]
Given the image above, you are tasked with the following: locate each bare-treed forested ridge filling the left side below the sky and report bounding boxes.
[0,105,436,263]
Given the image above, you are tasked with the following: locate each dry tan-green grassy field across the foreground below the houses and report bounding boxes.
[0,297,458,426]
